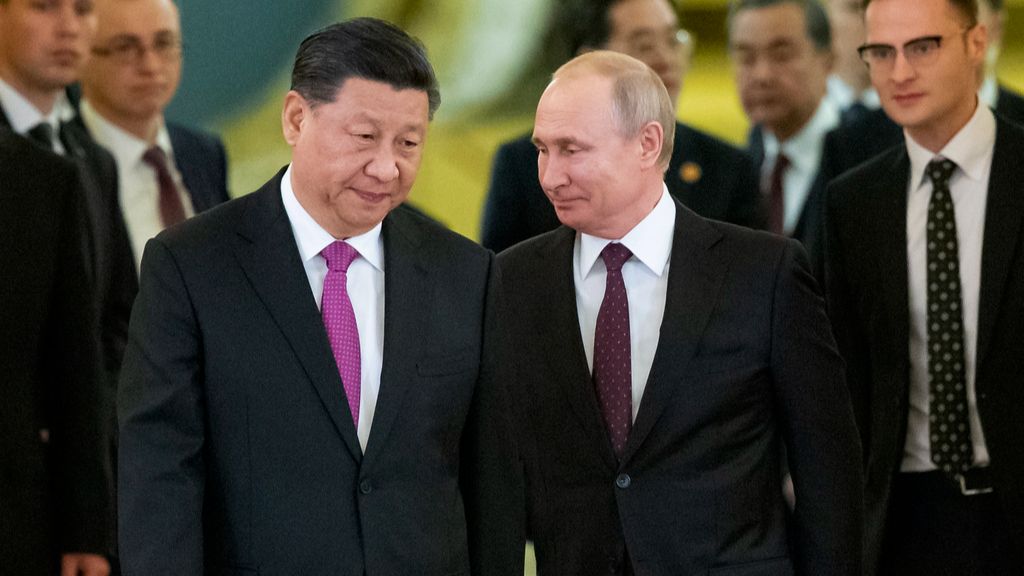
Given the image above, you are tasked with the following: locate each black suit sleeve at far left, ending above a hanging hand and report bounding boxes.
[51,171,114,554]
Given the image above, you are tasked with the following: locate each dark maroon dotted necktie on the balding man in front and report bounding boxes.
[594,243,633,456]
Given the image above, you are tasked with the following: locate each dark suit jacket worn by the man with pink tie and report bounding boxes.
[118,171,522,576]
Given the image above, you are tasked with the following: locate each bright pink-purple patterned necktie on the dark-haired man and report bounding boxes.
[321,240,361,428]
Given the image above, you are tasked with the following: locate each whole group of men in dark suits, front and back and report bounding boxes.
[0,0,1024,576]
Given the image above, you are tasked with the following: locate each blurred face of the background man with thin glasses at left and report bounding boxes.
[82,0,181,140]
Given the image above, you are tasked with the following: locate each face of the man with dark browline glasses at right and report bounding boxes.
[865,0,986,152]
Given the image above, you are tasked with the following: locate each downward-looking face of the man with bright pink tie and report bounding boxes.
[282,78,428,239]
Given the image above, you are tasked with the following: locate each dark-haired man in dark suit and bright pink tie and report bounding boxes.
[119,18,522,576]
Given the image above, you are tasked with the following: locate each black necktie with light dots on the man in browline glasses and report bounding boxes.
[926,159,974,478]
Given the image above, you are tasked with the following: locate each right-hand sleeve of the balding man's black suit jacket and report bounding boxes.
[771,236,863,576]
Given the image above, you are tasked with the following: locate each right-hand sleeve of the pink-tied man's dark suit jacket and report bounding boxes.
[460,254,525,576]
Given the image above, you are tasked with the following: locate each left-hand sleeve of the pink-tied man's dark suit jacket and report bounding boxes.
[118,238,206,576]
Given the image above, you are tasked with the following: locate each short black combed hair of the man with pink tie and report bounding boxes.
[292,17,441,118]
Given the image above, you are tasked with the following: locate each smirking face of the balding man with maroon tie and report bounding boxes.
[534,75,662,239]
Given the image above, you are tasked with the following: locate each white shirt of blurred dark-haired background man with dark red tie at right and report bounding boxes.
[761,97,840,235]
